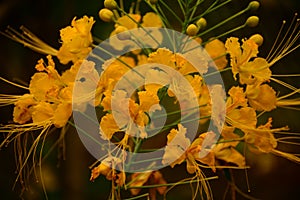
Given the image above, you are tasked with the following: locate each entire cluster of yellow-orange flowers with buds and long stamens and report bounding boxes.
[0,0,300,199]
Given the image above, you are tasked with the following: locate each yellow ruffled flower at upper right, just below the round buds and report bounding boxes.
[225,37,272,85]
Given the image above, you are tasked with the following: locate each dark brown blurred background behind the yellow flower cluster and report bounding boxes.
[0,0,300,200]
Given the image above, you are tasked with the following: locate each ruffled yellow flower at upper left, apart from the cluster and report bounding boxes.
[57,16,95,64]
